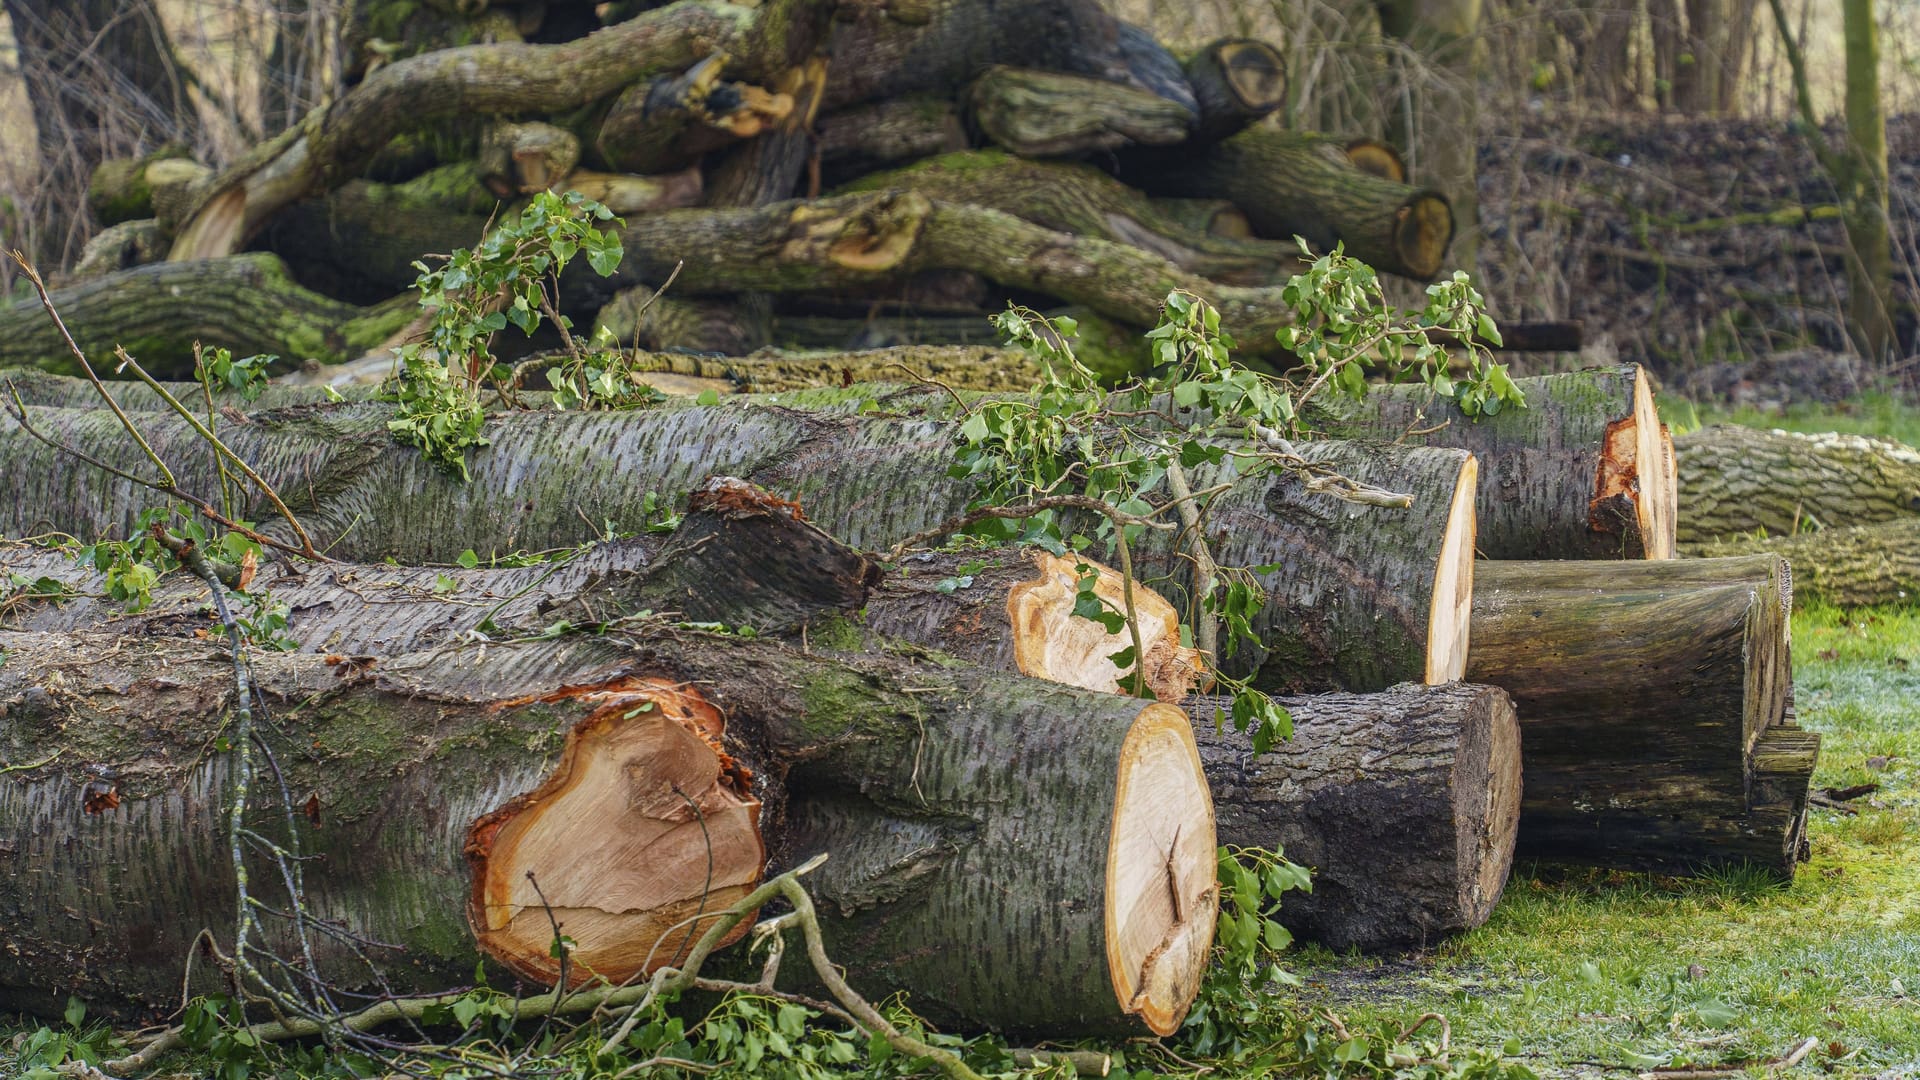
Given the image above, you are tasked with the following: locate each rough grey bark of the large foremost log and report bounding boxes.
[0,618,1213,1034]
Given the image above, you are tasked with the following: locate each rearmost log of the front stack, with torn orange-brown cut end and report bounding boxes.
[1313,365,1684,559]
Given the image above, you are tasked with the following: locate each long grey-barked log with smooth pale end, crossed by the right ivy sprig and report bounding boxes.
[0,404,1476,690]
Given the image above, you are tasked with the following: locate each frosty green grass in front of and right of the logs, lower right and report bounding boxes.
[1294,609,1920,1076]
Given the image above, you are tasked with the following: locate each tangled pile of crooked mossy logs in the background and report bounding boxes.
[0,0,1482,371]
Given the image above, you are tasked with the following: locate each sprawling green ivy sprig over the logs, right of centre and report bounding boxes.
[975,265,1524,751]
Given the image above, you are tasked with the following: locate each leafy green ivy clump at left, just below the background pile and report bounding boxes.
[388,192,648,479]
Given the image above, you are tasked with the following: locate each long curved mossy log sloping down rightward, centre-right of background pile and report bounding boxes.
[849,150,1302,286]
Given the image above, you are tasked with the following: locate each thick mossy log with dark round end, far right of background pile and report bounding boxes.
[1121,131,1453,281]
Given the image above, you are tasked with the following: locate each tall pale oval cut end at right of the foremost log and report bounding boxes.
[1106,703,1219,1036]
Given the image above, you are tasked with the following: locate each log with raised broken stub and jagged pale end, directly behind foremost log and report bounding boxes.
[0,479,1208,701]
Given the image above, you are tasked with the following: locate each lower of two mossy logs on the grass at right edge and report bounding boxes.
[1684,519,1920,607]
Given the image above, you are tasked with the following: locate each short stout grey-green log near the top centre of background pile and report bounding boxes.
[966,65,1198,158]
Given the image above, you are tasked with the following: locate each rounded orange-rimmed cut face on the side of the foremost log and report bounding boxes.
[467,678,766,986]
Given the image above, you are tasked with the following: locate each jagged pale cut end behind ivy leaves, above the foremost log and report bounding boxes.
[1006,552,1206,701]
